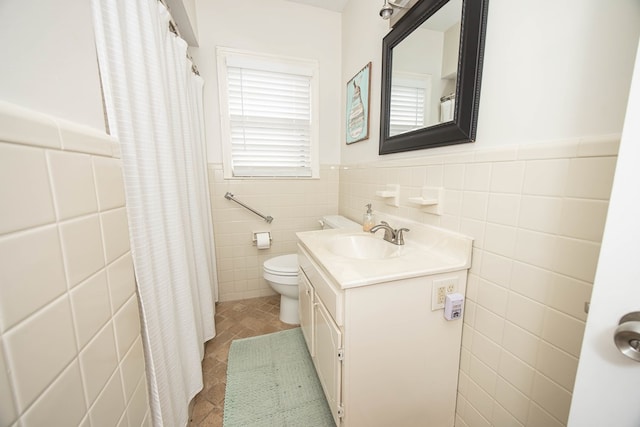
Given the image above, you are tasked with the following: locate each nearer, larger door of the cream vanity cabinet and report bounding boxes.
[314,302,342,425]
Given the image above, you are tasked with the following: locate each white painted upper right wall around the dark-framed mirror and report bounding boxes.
[341,0,640,164]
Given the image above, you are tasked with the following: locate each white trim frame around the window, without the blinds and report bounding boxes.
[216,46,320,179]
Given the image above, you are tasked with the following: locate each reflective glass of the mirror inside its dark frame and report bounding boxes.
[389,0,462,136]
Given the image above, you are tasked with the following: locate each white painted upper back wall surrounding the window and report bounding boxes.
[193,0,344,164]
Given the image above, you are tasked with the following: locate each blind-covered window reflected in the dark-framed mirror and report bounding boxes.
[389,75,431,136]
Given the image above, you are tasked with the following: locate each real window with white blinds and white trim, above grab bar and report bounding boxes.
[218,50,318,178]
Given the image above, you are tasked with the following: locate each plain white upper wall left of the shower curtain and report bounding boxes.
[0,0,105,130]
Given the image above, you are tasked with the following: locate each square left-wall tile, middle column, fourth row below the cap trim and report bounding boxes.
[78,322,118,405]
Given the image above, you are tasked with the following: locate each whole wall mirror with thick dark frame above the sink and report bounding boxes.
[379,0,488,154]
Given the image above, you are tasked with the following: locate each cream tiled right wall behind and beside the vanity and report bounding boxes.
[339,138,618,427]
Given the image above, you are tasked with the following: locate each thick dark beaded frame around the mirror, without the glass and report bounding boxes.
[379,0,489,154]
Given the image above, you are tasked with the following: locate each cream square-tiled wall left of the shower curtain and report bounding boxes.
[0,103,149,427]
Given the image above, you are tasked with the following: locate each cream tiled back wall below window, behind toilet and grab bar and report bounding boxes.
[209,164,340,301]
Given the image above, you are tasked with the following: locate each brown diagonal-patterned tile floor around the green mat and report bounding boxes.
[189,295,296,427]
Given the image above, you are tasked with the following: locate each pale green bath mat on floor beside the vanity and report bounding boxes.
[223,328,335,427]
